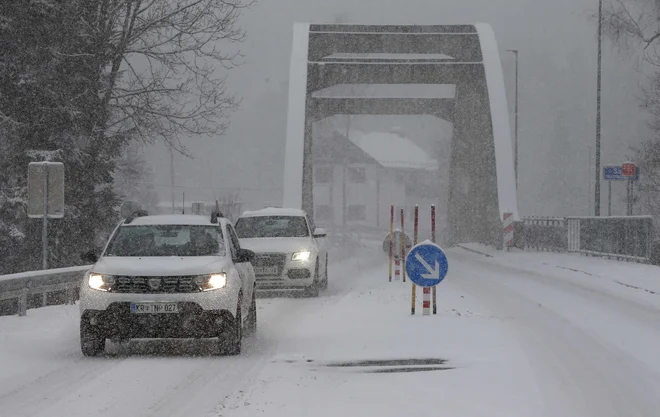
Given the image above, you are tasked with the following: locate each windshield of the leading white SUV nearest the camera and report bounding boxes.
[105,225,225,256]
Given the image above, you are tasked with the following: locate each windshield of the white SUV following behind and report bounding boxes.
[236,216,309,239]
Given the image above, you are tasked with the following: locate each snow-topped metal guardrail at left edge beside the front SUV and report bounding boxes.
[0,265,91,316]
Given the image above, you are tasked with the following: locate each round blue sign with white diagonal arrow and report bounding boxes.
[406,240,449,287]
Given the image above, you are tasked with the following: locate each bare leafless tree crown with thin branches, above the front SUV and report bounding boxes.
[80,0,253,152]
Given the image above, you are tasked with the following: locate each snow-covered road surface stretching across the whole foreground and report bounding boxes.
[0,247,660,417]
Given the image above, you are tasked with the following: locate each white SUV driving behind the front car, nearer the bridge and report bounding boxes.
[236,208,328,297]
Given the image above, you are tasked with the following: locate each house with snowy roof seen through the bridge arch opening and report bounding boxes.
[313,130,443,229]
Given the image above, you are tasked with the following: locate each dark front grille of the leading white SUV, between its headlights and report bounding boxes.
[111,276,201,294]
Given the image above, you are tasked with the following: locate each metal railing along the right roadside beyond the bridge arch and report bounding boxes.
[514,216,656,263]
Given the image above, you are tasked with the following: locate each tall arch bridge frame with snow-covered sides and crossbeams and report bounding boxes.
[283,23,519,246]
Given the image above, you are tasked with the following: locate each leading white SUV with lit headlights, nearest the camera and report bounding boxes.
[80,212,257,356]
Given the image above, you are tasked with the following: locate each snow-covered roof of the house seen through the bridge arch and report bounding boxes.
[350,131,438,170]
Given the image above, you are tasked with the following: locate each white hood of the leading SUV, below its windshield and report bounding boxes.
[92,256,229,277]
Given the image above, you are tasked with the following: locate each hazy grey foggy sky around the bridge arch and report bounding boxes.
[149,0,646,216]
